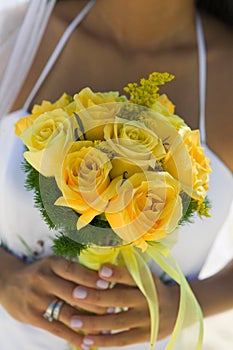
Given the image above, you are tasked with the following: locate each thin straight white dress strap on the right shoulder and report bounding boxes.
[196,14,207,144]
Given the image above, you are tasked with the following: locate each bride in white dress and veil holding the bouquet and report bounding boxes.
[0,0,233,350]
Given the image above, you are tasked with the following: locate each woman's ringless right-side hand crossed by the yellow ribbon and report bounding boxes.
[67,265,179,349]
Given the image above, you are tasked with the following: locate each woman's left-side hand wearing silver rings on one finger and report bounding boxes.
[0,251,111,346]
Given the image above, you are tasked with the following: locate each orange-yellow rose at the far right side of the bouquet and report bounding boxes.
[184,129,211,202]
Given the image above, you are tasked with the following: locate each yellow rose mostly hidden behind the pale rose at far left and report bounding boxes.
[15,93,71,136]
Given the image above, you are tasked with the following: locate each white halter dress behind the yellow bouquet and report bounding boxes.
[0,2,233,350]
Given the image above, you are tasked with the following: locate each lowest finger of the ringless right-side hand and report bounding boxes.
[82,328,150,349]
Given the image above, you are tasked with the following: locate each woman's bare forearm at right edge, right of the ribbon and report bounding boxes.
[190,260,233,317]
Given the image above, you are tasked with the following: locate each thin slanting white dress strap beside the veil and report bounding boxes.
[23,0,95,110]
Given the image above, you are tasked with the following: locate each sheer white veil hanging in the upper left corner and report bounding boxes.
[0,0,56,119]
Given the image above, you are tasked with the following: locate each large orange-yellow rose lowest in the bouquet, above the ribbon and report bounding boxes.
[105,171,182,249]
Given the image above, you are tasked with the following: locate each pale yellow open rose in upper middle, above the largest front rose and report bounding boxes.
[102,118,166,178]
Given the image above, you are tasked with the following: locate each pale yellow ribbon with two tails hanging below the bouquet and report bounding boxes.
[79,242,203,350]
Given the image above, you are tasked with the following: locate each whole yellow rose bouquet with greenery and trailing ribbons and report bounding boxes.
[15,73,210,349]
